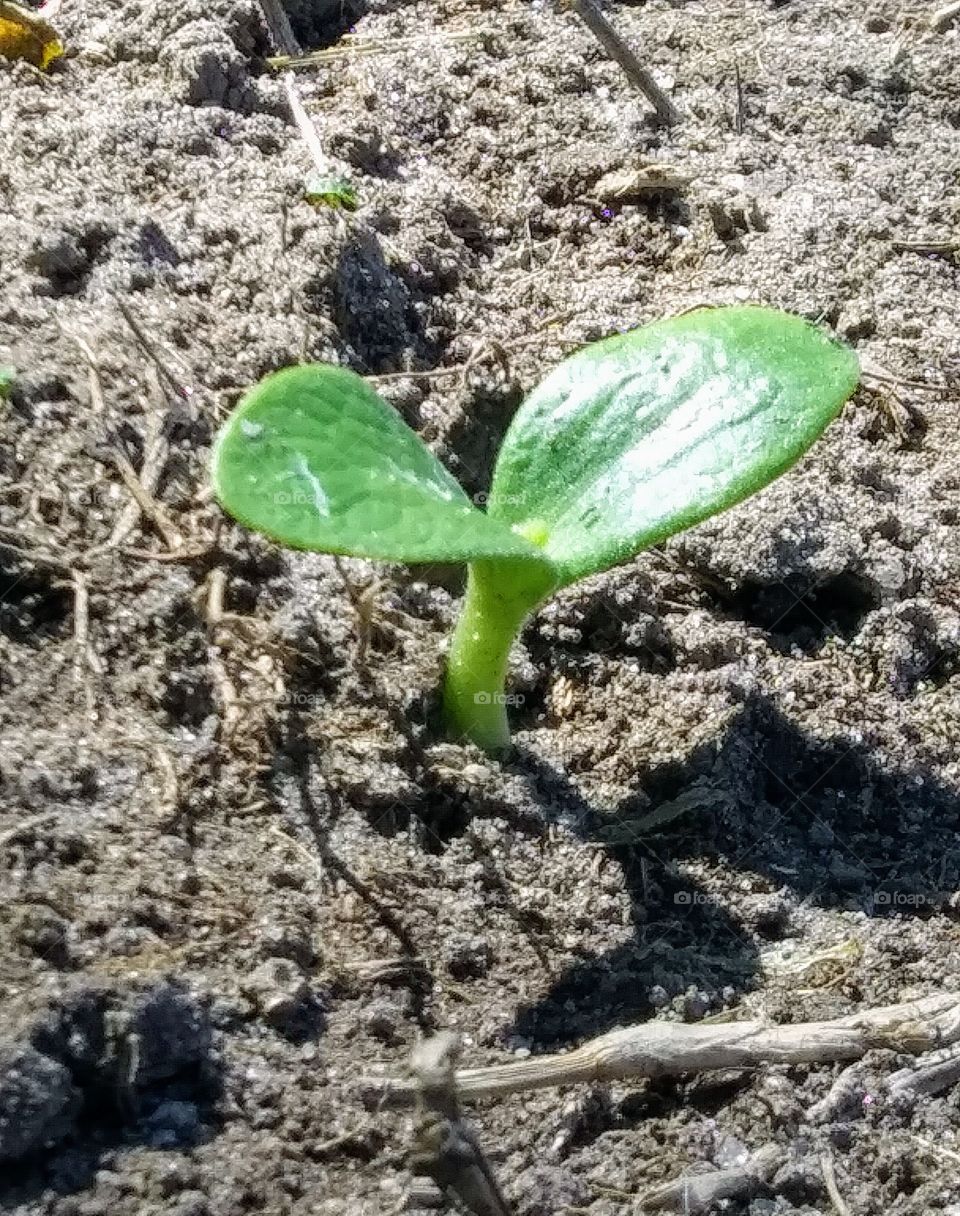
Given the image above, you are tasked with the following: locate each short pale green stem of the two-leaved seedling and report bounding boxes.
[443,562,555,751]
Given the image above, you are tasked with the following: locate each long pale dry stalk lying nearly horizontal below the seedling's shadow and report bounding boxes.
[367,992,960,1105]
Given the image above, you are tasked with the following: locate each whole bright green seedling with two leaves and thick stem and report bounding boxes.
[213,306,859,751]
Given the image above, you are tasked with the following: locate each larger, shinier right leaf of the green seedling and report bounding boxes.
[488,308,859,585]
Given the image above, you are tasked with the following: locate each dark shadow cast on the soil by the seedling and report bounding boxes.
[501,698,960,1042]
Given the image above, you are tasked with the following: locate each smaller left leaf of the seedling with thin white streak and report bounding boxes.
[213,364,548,567]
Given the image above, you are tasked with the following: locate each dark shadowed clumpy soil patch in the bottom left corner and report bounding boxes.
[0,983,223,1211]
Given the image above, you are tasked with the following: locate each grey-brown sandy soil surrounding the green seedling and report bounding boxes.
[0,0,960,1216]
